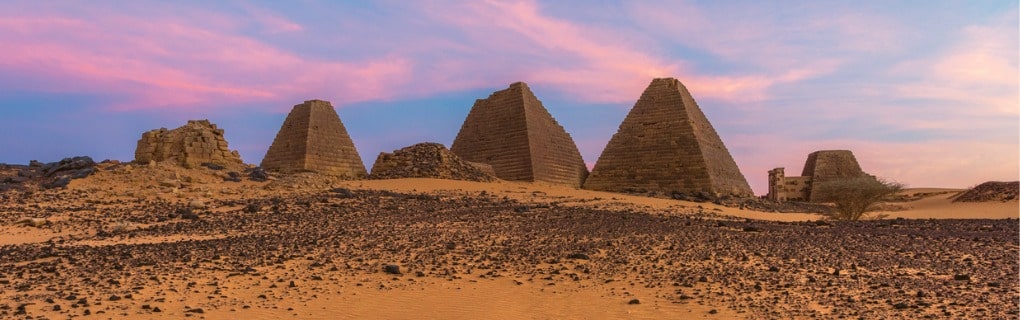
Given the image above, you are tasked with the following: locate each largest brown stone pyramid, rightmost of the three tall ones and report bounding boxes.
[584,77,753,197]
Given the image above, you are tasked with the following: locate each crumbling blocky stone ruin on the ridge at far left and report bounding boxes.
[135,120,244,168]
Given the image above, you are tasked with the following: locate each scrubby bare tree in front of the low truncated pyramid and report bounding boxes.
[813,175,904,220]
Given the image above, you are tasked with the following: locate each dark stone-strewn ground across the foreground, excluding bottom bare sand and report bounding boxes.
[0,182,1020,319]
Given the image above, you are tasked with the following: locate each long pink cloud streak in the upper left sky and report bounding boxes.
[0,7,410,110]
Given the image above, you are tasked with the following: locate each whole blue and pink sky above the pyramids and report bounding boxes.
[0,0,1020,195]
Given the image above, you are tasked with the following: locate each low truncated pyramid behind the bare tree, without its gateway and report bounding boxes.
[801,150,868,202]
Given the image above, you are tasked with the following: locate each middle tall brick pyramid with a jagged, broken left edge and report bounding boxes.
[450,83,588,188]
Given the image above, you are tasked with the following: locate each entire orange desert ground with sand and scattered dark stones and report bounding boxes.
[0,164,1020,319]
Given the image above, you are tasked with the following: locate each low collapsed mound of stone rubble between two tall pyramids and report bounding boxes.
[368,143,496,181]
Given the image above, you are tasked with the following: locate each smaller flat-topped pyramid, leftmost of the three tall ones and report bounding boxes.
[262,100,367,178]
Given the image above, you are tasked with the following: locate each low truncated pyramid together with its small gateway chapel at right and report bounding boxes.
[765,150,870,202]
